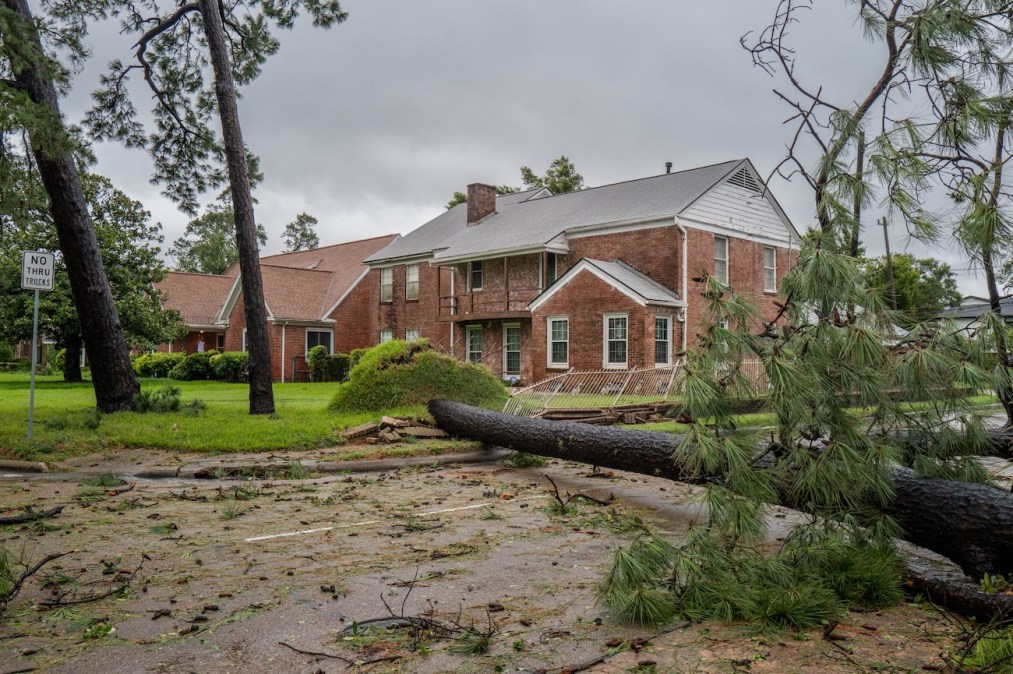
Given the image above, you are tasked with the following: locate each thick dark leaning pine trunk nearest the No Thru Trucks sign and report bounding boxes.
[0,0,141,413]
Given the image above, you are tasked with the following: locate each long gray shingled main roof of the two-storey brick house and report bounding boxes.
[366,159,746,263]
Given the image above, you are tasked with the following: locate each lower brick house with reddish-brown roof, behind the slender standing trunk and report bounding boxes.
[157,234,397,382]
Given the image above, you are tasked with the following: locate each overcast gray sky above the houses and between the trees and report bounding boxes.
[64,0,981,293]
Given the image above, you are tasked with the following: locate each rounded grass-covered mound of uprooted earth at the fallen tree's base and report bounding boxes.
[330,340,507,410]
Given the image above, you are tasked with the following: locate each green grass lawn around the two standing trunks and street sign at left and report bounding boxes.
[0,374,424,460]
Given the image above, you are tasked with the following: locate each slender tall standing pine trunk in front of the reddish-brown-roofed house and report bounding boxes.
[200,0,275,415]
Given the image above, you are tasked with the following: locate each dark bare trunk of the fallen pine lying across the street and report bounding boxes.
[430,400,1013,616]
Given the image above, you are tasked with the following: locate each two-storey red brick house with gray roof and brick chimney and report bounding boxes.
[366,159,799,382]
